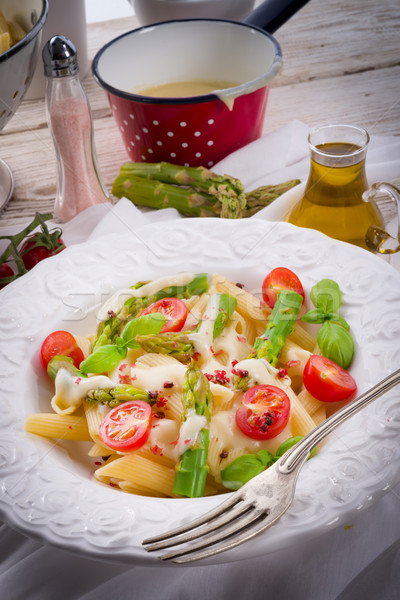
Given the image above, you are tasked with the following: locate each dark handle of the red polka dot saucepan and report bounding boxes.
[243,0,309,33]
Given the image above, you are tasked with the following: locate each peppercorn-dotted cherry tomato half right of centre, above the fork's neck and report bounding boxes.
[236,385,290,440]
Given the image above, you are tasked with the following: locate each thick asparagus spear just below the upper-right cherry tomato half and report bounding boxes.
[235,290,303,390]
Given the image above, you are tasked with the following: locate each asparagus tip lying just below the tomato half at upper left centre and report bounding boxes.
[135,331,194,364]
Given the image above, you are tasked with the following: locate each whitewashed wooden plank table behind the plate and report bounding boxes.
[0,0,400,228]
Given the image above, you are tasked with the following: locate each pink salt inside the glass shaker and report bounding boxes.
[50,98,108,222]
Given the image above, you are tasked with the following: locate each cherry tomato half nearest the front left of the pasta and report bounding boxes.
[99,400,151,452]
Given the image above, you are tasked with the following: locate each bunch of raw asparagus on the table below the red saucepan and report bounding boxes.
[112,162,300,219]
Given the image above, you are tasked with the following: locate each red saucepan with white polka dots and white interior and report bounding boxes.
[93,0,307,167]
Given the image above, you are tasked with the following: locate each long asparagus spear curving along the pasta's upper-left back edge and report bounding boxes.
[92,273,208,352]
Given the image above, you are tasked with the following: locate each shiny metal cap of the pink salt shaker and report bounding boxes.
[42,35,79,77]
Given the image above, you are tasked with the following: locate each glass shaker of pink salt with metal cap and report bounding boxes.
[42,35,109,222]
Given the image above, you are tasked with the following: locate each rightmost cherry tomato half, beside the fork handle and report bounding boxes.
[303,354,357,402]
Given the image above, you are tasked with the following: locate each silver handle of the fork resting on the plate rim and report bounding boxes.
[278,369,400,474]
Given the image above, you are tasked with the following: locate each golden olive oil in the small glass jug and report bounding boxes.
[287,142,383,248]
